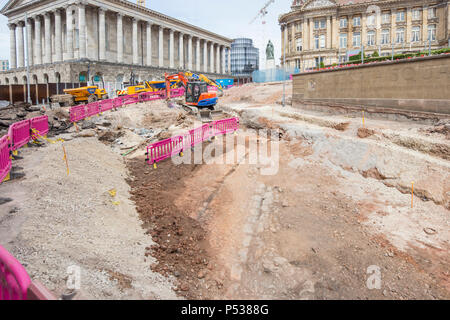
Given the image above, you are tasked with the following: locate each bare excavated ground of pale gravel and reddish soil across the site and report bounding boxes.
[0,84,450,299]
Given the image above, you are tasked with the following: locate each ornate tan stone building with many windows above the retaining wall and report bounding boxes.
[279,0,450,70]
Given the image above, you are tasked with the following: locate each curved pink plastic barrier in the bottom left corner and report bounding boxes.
[0,246,31,300]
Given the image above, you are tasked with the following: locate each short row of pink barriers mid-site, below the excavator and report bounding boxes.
[146,118,239,165]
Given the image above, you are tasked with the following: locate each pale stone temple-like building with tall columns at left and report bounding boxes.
[0,0,232,94]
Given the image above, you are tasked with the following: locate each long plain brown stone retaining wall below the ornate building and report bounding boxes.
[293,55,450,114]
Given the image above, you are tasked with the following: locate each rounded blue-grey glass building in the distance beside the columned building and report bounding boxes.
[227,38,259,77]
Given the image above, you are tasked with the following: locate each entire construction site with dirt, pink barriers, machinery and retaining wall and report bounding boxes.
[0,1,450,306]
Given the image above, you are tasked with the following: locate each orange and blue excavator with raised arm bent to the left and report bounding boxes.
[165,72,218,110]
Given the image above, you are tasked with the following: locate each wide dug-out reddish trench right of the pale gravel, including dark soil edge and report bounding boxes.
[127,122,450,299]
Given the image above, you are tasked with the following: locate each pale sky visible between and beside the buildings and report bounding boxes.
[0,0,292,69]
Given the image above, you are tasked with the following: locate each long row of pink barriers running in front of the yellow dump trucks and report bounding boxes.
[70,88,184,122]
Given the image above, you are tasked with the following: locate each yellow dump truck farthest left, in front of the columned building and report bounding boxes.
[50,86,108,107]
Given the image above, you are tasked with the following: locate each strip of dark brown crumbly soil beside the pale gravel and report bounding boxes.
[127,158,209,299]
